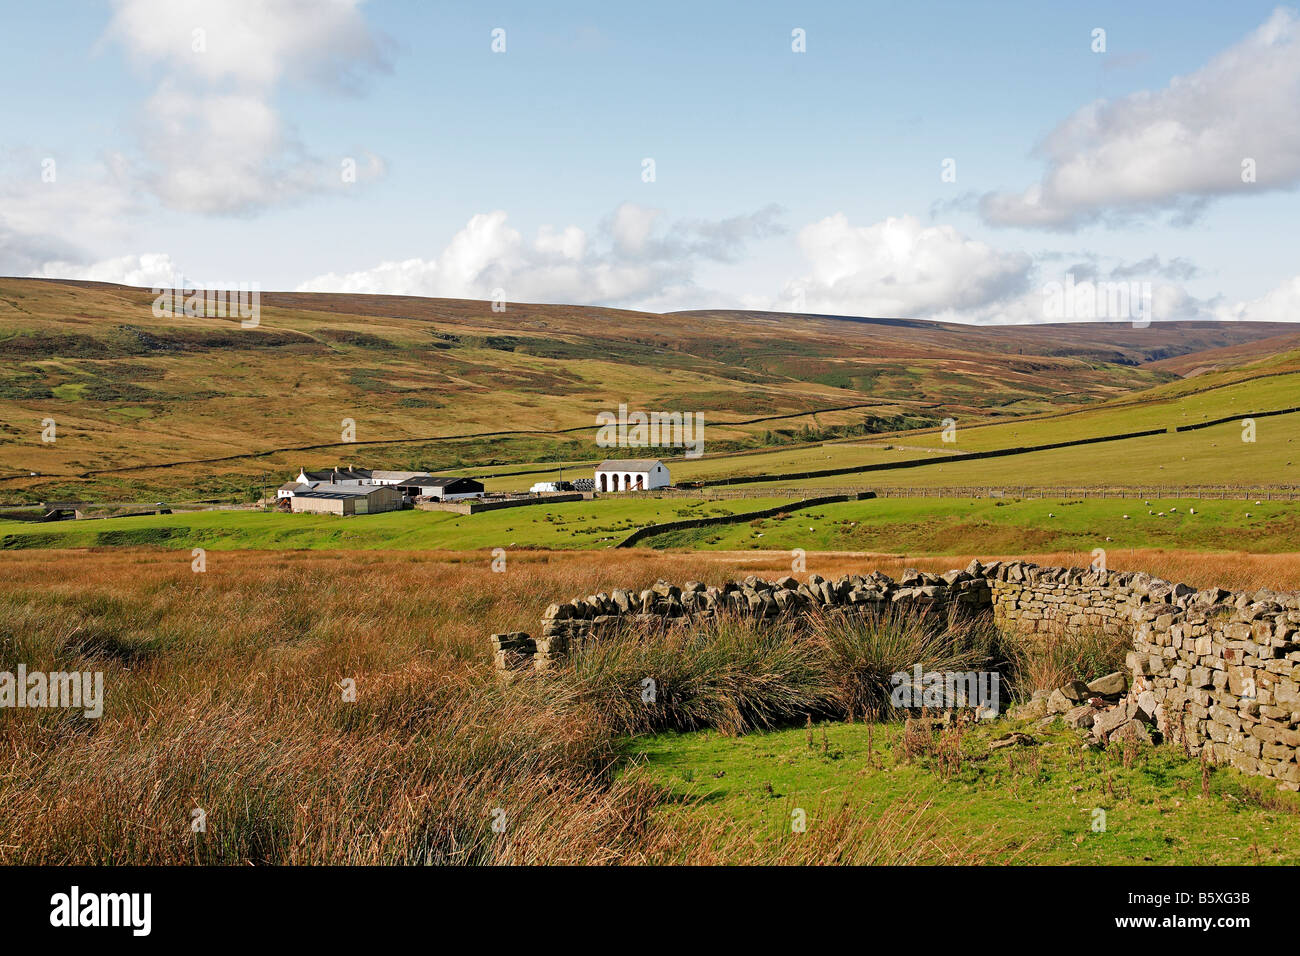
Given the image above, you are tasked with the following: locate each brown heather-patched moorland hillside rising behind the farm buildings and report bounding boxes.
[0,278,1294,501]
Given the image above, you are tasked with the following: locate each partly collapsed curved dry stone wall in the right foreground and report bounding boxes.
[491,561,1300,790]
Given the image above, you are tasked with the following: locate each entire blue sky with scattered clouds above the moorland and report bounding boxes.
[0,0,1300,323]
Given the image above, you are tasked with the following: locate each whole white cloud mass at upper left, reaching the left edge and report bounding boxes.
[0,0,387,284]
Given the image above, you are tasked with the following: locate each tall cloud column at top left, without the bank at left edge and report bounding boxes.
[105,0,389,215]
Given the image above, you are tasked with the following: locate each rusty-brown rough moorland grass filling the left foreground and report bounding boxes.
[0,553,1024,865]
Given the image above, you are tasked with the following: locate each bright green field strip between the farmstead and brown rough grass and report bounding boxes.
[0,497,1300,555]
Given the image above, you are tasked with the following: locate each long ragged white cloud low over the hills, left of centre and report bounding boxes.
[298,203,781,308]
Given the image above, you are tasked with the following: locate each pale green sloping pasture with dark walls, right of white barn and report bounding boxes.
[481,356,1300,494]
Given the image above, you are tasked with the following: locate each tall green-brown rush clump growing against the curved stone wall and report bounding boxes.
[559,611,1010,735]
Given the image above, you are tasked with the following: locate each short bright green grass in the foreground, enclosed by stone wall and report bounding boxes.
[628,721,1300,865]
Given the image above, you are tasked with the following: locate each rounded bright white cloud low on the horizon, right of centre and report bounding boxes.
[776,213,1032,319]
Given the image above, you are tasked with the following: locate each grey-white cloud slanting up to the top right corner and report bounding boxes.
[980,8,1300,229]
